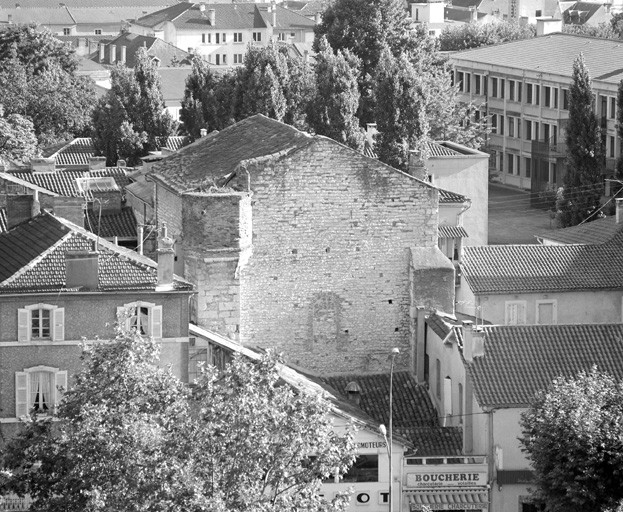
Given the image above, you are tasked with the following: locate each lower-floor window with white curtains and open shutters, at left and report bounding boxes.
[15,366,67,418]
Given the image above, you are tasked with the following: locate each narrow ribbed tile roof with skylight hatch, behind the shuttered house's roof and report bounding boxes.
[6,167,130,197]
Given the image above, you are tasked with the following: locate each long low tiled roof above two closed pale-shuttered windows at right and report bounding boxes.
[461,242,623,294]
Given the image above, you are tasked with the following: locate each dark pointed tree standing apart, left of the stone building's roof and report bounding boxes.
[93,48,175,165]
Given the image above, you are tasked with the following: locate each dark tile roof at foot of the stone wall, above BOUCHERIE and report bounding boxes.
[324,372,462,456]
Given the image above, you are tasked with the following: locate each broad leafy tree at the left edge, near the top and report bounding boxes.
[0,26,95,145]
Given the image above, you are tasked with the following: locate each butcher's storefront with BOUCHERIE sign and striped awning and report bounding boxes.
[402,457,489,512]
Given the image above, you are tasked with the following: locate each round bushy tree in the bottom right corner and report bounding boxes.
[519,368,623,512]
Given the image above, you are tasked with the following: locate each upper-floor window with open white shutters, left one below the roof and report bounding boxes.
[17,304,65,341]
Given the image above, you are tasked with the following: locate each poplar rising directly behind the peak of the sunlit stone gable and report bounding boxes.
[307,38,364,150]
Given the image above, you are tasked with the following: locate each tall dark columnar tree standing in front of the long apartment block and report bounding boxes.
[559,54,605,227]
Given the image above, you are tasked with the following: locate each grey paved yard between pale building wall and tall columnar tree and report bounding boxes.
[489,183,555,245]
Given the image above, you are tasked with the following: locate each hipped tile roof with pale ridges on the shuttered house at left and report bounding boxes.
[0,212,193,293]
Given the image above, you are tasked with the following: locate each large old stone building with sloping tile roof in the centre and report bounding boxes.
[150,115,456,374]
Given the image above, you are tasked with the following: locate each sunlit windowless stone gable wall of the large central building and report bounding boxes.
[240,138,438,374]
